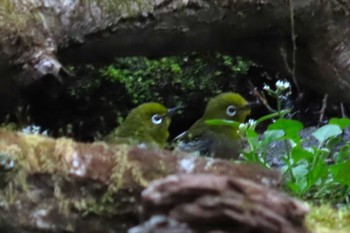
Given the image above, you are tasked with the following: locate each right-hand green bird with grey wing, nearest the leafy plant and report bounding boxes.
[174,92,256,158]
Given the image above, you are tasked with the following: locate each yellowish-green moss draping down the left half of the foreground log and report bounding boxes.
[0,133,141,216]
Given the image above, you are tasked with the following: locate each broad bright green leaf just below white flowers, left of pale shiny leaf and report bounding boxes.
[268,119,304,144]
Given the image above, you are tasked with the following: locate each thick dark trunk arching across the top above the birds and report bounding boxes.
[0,0,350,102]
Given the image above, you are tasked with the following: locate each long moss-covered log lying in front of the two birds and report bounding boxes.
[0,130,281,233]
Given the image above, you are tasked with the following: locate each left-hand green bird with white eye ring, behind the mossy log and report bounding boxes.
[106,102,177,148]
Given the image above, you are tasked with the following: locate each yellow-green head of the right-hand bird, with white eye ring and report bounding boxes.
[202,92,250,122]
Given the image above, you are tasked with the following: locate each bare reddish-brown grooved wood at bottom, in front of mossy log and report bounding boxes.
[133,174,308,233]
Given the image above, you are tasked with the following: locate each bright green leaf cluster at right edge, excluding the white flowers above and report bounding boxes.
[244,119,350,203]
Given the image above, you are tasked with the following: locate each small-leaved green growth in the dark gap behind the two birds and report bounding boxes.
[100,54,251,105]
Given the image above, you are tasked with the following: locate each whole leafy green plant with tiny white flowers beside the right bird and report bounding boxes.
[208,82,350,204]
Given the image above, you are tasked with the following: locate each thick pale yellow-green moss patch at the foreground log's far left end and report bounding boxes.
[0,135,72,206]
